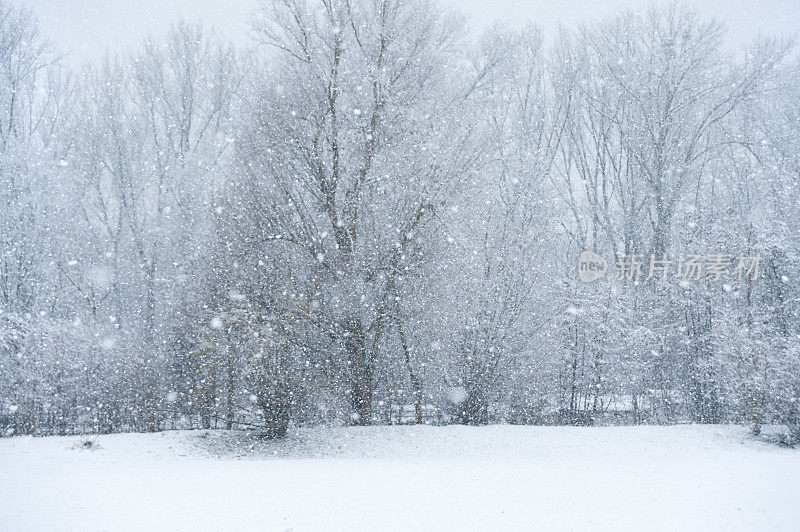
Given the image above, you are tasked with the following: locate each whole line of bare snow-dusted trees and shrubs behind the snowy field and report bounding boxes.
[0,0,800,438]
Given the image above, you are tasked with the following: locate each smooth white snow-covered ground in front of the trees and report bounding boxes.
[0,426,800,531]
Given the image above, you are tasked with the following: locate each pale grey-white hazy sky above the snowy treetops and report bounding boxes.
[17,0,800,63]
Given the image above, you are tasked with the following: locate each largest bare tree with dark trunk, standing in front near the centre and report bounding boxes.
[242,0,482,424]
